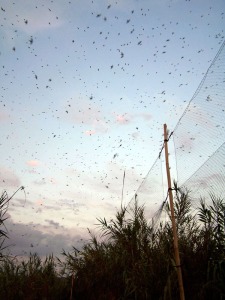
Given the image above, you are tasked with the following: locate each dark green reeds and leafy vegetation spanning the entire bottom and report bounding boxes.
[0,187,225,300]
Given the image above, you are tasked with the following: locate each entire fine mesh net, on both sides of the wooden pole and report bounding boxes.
[129,42,225,223]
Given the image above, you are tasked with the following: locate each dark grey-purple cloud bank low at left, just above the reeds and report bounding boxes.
[4,219,88,257]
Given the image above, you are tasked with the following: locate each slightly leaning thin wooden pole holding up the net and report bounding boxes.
[164,124,185,300]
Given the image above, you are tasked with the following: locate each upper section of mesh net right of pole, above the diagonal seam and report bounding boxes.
[173,43,225,186]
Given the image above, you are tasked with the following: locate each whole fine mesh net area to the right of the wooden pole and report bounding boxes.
[173,39,225,197]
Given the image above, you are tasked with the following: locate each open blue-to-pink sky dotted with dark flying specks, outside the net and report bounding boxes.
[0,0,225,256]
